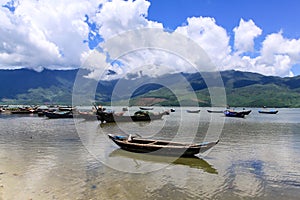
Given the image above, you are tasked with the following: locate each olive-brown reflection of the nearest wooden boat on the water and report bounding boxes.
[109,149,218,174]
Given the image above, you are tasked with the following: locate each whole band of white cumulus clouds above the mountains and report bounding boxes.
[0,0,300,78]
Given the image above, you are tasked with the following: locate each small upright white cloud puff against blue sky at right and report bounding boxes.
[233,19,262,53]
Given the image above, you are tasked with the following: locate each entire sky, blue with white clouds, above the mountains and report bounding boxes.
[0,0,300,78]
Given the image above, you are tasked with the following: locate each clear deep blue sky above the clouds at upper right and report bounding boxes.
[148,0,300,75]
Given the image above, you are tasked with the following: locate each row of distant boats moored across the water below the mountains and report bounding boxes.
[0,106,278,119]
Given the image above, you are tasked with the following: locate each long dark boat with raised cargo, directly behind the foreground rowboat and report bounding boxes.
[97,111,166,123]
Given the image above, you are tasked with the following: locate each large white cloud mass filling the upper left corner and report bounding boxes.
[0,0,99,70]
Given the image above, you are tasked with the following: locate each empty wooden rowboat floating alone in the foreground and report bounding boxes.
[108,134,219,157]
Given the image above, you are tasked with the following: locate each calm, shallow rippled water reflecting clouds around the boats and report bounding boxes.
[0,108,300,200]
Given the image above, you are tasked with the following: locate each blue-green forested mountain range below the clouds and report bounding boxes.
[0,69,300,107]
